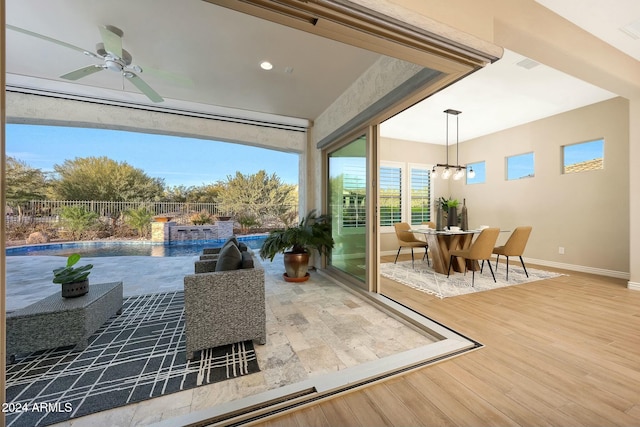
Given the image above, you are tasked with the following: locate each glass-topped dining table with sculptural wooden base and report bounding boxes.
[408,227,490,274]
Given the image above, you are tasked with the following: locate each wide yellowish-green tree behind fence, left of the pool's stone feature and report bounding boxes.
[53,157,164,201]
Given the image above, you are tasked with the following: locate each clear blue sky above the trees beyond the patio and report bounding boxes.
[6,124,299,187]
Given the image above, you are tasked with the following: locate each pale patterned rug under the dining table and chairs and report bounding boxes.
[380,260,561,298]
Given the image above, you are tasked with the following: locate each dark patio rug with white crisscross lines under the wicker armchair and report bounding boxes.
[3,291,260,427]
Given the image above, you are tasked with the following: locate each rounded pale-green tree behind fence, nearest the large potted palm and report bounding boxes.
[219,170,297,225]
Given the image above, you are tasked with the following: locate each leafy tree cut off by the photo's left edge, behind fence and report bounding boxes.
[5,157,49,215]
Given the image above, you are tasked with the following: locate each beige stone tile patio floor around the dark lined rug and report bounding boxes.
[6,256,436,427]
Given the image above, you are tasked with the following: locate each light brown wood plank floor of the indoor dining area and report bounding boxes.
[249,258,640,427]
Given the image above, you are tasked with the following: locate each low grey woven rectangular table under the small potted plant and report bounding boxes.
[6,282,122,363]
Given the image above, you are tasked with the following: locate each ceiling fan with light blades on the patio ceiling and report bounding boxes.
[7,24,164,102]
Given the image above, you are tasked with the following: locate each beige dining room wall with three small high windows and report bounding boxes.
[382,98,630,277]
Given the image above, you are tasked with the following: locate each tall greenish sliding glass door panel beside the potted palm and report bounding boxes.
[328,135,368,289]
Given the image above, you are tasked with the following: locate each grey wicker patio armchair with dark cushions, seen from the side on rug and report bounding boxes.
[184,239,267,360]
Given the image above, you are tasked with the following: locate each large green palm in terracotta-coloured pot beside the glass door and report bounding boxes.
[260,209,334,282]
